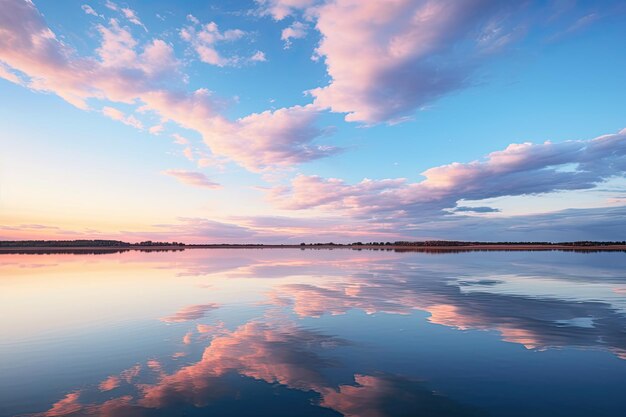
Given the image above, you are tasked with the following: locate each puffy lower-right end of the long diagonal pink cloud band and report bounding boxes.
[142,89,332,172]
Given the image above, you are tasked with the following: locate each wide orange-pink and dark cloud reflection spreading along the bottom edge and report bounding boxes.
[31,314,472,417]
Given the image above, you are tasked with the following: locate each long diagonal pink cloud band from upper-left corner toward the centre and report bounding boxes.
[0,0,336,171]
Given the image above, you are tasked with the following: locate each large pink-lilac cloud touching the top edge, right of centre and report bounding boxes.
[310,0,513,123]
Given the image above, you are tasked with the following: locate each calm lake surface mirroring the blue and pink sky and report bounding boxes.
[0,249,626,417]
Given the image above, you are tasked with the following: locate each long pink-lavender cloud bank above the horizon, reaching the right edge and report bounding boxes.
[267,129,626,220]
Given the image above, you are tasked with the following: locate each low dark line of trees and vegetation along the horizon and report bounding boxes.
[0,239,626,254]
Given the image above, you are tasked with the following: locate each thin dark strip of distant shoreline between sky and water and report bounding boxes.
[0,243,626,254]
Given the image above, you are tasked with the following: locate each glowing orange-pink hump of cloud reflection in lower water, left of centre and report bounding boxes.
[139,322,342,407]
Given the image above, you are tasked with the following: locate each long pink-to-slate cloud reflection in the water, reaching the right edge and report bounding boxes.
[268,261,626,357]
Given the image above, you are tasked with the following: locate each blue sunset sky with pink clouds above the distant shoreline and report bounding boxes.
[0,0,626,243]
